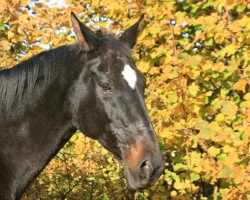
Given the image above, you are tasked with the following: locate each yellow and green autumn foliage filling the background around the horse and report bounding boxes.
[0,0,250,200]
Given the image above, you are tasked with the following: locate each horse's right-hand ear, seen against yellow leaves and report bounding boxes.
[120,14,144,49]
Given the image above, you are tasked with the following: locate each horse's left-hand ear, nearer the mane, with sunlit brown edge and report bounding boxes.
[71,12,100,51]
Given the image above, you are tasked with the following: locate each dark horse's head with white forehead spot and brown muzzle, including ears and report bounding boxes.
[71,13,165,189]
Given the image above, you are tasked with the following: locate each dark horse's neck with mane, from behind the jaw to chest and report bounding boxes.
[0,44,86,195]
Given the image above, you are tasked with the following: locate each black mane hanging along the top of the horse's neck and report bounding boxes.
[0,45,70,108]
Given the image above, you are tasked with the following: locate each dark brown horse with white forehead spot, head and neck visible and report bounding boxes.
[0,12,165,200]
